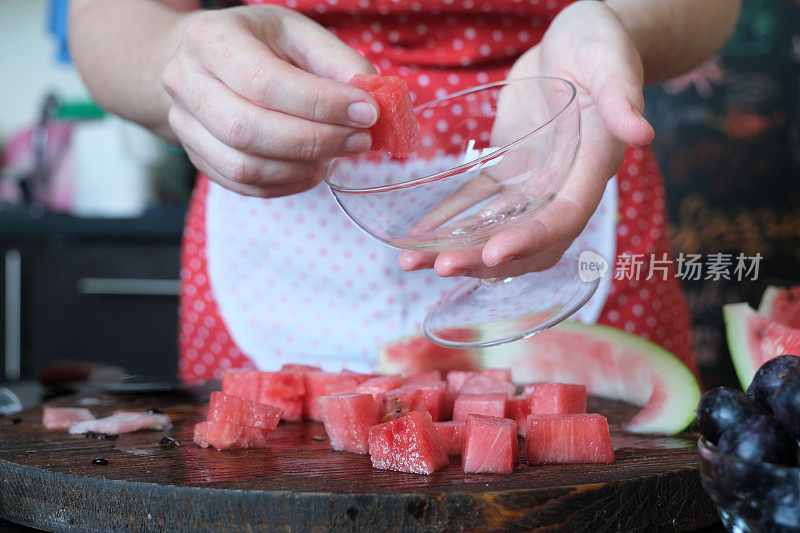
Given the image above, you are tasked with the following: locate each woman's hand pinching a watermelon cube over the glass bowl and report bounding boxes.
[162,6,379,198]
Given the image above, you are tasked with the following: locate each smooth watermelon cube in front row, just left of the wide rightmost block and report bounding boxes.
[462,415,519,474]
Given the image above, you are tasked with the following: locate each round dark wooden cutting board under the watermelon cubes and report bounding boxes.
[0,393,716,531]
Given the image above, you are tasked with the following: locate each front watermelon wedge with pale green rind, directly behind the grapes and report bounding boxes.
[722,303,800,389]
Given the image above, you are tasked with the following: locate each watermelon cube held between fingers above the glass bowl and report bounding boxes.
[350,74,419,159]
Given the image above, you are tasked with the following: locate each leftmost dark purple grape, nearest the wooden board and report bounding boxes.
[697,387,763,444]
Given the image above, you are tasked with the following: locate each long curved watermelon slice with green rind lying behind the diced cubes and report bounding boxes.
[379,322,700,435]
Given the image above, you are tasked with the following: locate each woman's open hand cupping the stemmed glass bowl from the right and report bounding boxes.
[400,1,653,278]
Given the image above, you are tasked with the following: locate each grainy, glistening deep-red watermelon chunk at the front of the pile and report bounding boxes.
[369,411,448,474]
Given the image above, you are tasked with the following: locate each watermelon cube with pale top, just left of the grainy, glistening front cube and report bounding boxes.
[317,393,378,453]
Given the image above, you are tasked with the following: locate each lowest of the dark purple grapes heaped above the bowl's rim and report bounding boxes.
[718,415,795,465]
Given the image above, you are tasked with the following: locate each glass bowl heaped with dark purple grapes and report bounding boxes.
[697,355,800,532]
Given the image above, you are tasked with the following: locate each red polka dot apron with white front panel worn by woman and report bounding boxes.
[179,0,694,382]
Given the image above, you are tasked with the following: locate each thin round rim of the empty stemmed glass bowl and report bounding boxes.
[324,76,580,194]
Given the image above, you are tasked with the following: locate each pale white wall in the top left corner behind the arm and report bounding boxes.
[0,0,88,142]
